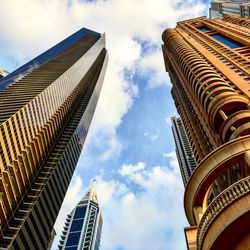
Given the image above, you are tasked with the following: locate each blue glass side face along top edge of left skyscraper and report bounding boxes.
[0,28,101,90]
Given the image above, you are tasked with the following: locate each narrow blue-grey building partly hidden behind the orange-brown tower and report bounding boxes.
[171,117,196,186]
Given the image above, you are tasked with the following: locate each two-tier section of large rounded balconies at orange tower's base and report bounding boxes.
[184,136,250,250]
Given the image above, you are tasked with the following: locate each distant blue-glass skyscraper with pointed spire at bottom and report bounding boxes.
[58,180,103,250]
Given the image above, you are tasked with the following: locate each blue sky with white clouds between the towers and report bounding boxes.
[0,0,209,250]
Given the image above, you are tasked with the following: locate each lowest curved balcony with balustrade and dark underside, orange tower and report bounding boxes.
[197,176,250,249]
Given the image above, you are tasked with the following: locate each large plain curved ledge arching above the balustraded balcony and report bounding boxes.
[184,135,250,226]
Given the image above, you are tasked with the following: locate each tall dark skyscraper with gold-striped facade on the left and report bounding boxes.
[0,28,107,249]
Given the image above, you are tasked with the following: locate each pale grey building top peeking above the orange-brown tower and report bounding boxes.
[209,0,250,18]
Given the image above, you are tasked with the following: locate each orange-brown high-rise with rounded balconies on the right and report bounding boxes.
[162,16,250,250]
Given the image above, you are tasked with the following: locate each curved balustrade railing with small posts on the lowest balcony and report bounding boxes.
[197,176,250,249]
